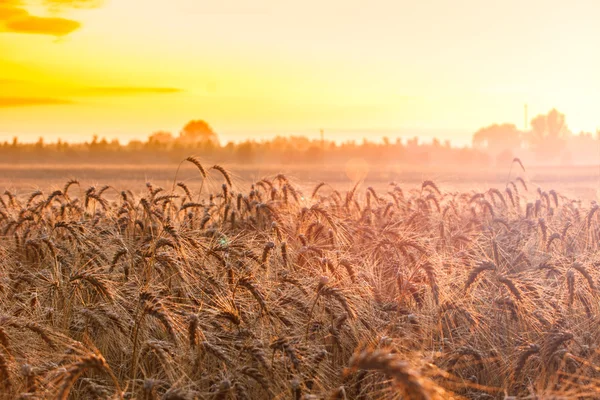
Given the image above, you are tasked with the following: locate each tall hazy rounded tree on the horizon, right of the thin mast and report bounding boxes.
[527,109,570,160]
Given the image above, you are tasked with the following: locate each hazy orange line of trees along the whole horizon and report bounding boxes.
[0,109,600,166]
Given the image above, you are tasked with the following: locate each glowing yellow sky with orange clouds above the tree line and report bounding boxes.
[0,0,600,144]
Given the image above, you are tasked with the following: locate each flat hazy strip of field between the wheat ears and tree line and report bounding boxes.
[0,160,600,201]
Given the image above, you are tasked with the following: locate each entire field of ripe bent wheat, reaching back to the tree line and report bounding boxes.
[0,158,600,400]
